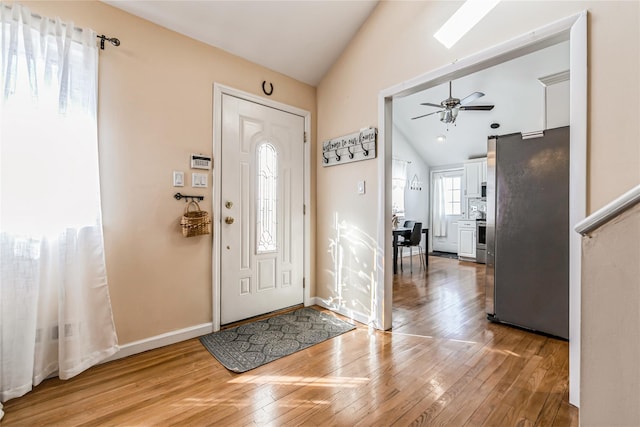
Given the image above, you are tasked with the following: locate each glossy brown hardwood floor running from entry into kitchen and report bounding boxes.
[0,257,578,427]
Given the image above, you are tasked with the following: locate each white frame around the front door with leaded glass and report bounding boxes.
[211,83,311,332]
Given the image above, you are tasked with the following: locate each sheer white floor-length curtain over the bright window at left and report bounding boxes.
[0,3,118,416]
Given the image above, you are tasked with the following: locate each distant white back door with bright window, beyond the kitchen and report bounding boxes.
[431,169,464,253]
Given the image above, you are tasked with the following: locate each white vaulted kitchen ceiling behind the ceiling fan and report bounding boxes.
[393,42,569,166]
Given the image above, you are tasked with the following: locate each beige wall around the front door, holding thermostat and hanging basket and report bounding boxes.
[22,1,316,344]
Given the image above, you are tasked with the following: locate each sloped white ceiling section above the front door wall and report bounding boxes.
[103,0,378,86]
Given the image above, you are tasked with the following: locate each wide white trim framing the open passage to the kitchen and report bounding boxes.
[372,11,588,407]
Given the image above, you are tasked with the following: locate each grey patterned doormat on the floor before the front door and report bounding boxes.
[200,308,355,372]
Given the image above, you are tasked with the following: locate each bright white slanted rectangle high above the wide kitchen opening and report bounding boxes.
[433,0,500,49]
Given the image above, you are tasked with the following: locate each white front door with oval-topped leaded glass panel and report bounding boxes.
[220,94,304,324]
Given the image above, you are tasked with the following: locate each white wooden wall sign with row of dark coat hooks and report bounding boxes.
[321,128,378,166]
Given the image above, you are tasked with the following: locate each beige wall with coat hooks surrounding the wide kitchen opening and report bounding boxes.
[316,1,640,315]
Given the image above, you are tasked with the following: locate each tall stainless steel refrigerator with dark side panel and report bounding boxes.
[485,127,569,339]
